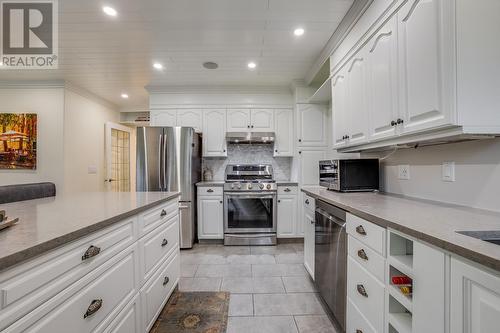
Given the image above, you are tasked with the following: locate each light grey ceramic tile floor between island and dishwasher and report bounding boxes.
[179,244,335,333]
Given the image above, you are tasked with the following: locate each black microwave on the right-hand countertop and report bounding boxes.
[319,158,379,192]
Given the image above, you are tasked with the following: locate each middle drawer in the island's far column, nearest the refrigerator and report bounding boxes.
[139,216,179,282]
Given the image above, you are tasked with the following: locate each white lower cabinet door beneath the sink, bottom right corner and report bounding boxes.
[450,258,500,333]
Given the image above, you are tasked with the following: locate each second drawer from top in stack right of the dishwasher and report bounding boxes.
[347,235,385,284]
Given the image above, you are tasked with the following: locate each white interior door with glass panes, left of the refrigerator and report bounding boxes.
[104,122,132,192]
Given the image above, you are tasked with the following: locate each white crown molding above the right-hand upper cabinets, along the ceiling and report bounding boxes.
[305,0,375,85]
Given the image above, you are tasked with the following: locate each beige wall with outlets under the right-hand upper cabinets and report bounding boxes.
[366,138,500,211]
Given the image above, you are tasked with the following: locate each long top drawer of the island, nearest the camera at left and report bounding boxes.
[0,218,136,330]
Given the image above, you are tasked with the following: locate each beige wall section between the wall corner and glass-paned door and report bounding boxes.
[64,89,119,192]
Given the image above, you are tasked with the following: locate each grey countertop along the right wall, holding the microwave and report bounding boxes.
[302,186,500,271]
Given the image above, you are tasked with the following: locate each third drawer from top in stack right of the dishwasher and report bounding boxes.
[347,256,385,332]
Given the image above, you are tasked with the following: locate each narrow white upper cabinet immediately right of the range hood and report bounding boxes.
[274,109,294,157]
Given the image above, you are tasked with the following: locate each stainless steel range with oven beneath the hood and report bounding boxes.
[224,165,278,245]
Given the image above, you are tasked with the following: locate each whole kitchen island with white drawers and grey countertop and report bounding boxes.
[0,192,180,332]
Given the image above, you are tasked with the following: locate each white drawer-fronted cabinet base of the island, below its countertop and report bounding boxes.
[0,199,180,333]
